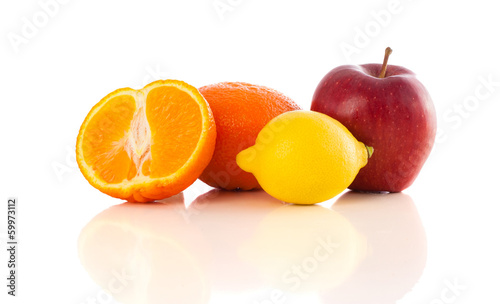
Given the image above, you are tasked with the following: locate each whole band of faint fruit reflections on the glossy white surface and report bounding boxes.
[79,190,426,303]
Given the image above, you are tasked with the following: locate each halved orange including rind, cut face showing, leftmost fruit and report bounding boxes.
[76,80,216,202]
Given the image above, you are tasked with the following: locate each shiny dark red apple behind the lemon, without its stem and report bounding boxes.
[311,64,437,192]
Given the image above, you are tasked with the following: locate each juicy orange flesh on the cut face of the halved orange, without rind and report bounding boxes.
[83,87,202,184]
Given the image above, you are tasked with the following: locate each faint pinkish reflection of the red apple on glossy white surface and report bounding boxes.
[323,191,427,304]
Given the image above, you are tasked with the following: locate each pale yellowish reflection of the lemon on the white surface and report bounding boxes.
[245,205,367,293]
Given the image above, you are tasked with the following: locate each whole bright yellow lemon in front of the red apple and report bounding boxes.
[236,111,373,204]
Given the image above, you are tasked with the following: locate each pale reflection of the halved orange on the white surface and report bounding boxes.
[78,195,210,304]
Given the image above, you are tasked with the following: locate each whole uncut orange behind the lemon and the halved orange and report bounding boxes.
[199,82,300,190]
